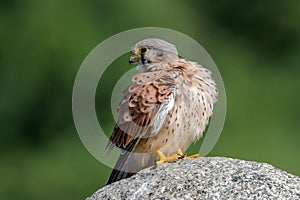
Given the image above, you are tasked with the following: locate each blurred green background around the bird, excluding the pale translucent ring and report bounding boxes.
[0,0,300,200]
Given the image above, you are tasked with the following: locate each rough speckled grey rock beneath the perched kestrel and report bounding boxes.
[88,157,300,200]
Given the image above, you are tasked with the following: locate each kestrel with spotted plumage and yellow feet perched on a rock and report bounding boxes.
[106,38,218,185]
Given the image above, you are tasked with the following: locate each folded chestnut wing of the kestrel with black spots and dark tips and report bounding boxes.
[107,71,175,151]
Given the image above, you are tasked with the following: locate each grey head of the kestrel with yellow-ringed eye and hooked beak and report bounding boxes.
[129,38,178,66]
